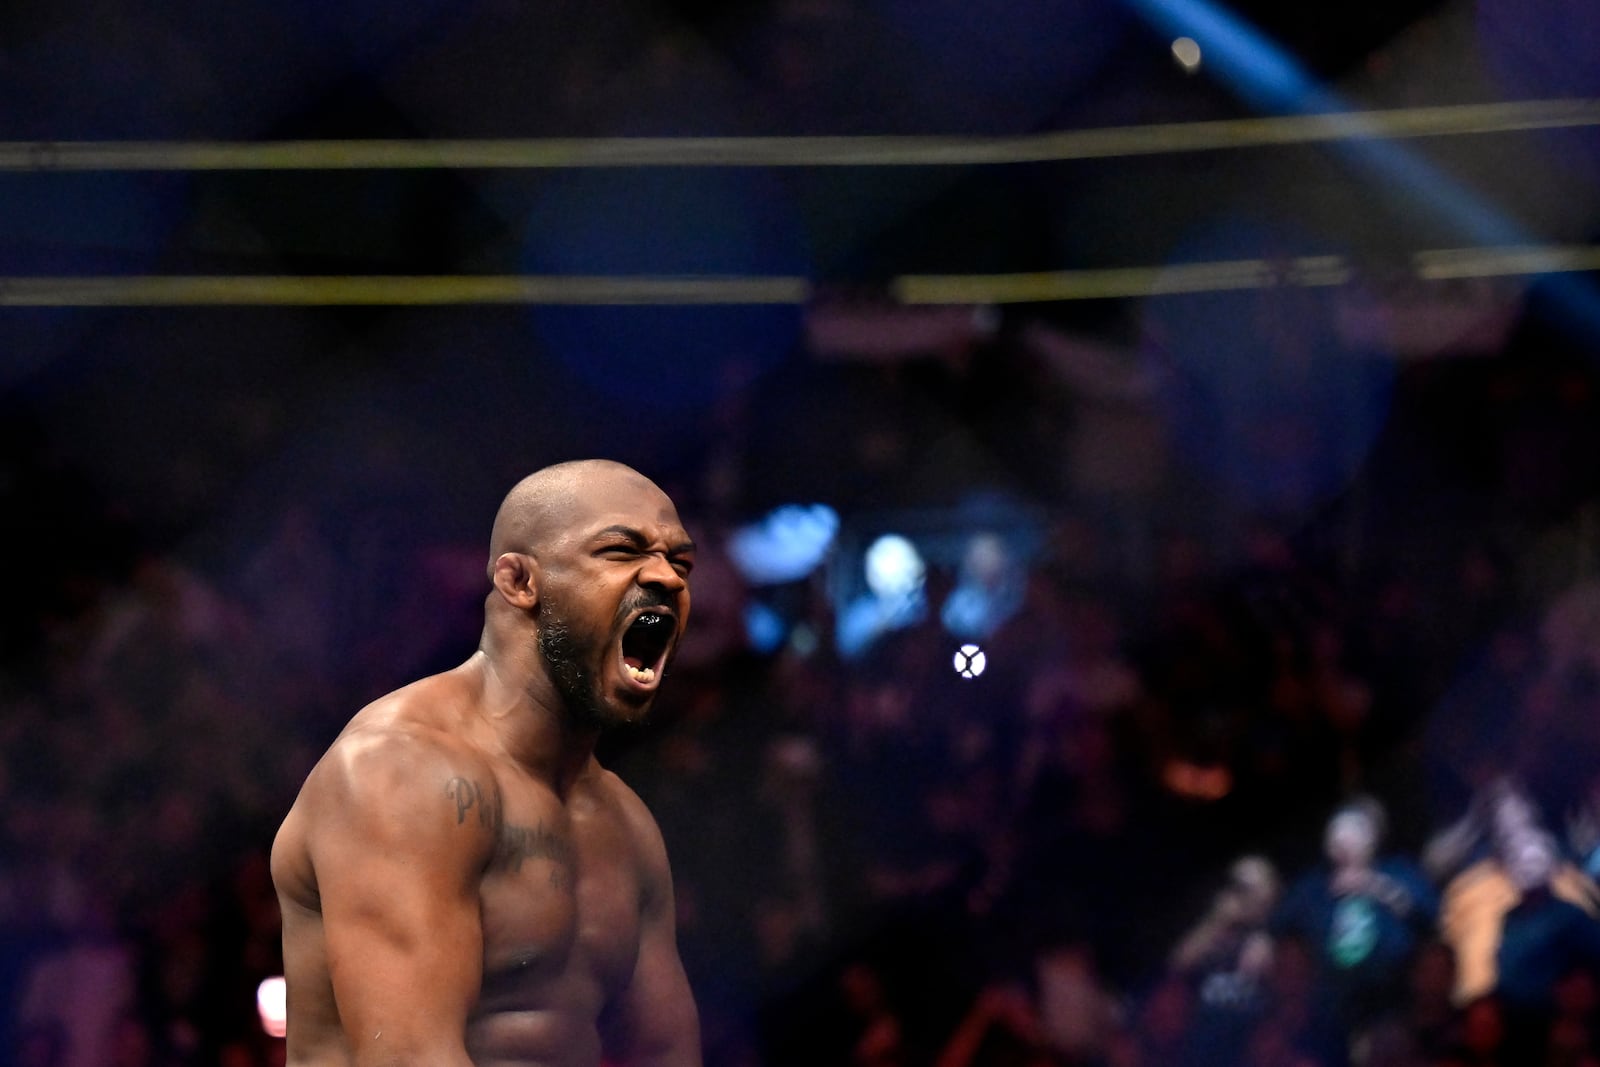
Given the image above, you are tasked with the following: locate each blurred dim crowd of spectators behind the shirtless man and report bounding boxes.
[0,294,1600,1067]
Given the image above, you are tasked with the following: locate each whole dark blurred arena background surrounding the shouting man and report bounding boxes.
[9,0,1600,1067]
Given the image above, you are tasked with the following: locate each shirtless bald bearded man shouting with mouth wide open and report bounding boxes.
[272,461,701,1067]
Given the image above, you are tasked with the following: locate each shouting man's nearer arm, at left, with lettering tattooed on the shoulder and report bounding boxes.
[307,729,493,1067]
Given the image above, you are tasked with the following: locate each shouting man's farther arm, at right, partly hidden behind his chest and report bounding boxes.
[605,785,701,1067]
